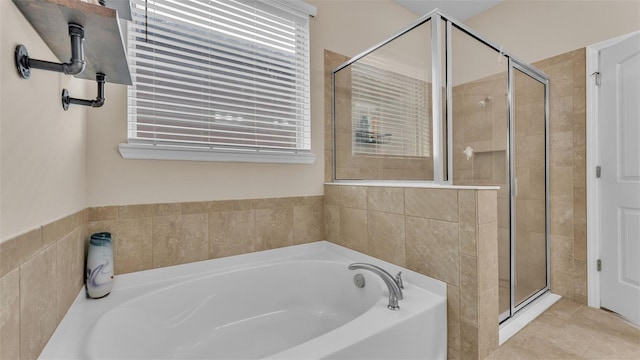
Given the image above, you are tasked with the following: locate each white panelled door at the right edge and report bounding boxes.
[597,34,640,325]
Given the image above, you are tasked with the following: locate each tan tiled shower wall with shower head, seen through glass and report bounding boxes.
[453,72,546,312]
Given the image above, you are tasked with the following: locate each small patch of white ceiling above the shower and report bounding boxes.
[394,0,503,21]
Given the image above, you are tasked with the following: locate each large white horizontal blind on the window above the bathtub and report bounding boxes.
[128,0,311,152]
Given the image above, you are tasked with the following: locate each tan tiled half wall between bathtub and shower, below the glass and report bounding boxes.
[324,184,498,359]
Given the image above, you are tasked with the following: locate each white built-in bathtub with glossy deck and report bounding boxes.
[40,241,447,359]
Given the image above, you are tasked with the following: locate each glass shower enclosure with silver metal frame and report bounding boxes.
[332,10,549,322]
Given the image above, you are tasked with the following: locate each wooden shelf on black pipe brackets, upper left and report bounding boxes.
[13,0,132,85]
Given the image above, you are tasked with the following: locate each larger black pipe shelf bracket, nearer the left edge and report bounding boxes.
[15,23,85,79]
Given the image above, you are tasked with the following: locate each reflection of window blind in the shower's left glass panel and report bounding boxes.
[351,59,431,156]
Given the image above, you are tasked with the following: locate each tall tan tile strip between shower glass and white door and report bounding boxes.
[533,48,587,304]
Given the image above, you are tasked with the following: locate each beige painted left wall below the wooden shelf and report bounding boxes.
[0,0,88,241]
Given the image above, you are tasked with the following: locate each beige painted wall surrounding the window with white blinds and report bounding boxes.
[87,0,417,206]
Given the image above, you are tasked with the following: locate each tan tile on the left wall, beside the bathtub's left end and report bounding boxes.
[0,210,87,359]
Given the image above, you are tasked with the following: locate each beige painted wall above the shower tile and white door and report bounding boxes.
[465,0,640,63]
